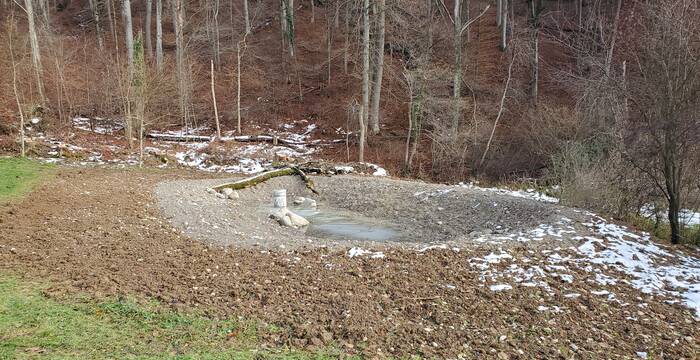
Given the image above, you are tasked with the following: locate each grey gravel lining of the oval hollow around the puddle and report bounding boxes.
[154,175,580,249]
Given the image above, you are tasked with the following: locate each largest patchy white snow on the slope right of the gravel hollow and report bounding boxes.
[470,213,700,317]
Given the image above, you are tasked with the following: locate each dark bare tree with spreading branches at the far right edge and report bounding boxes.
[623,0,700,244]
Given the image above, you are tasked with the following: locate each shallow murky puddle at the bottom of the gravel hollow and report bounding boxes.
[291,207,400,241]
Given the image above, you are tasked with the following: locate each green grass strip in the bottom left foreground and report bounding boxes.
[0,273,339,360]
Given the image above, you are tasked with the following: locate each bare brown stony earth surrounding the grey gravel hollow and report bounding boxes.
[0,169,700,359]
